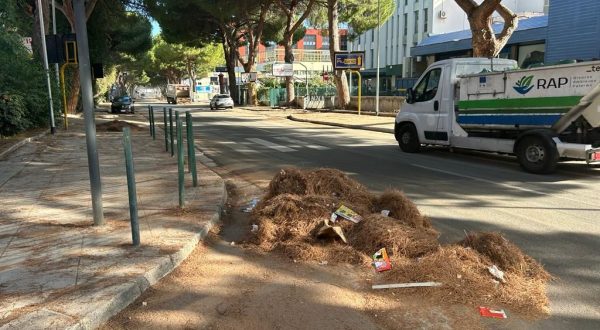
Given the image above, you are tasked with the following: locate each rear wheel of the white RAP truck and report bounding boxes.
[516,135,559,174]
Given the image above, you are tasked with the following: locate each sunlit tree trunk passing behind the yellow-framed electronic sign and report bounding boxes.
[327,0,350,109]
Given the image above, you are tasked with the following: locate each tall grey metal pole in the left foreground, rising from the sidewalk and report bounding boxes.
[73,0,104,226]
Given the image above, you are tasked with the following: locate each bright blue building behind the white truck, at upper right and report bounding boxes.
[411,0,600,73]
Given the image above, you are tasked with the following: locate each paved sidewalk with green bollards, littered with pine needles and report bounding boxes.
[0,113,226,329]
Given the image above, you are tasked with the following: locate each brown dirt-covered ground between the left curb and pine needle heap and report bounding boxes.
[102,180,485,329]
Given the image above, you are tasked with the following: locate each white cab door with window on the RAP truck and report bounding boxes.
[413,67,448,143]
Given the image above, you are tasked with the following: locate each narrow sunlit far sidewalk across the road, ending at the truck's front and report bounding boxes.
[238,107,395,134]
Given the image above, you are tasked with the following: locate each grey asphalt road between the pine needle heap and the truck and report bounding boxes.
[146,102,600,329]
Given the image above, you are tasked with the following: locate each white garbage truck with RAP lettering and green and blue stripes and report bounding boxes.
[394,58,600,173]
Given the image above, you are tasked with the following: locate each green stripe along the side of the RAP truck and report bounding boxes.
[458,96,582,110]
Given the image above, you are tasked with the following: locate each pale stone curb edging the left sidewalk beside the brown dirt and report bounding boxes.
[67,179,227,330]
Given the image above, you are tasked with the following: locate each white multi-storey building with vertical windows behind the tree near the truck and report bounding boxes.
[349,0,548,88]
